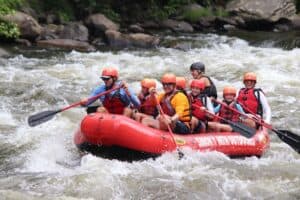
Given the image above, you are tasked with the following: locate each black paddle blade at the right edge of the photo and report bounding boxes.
[272,129,300,153]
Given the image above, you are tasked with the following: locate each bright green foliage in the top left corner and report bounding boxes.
[0,0,22,40]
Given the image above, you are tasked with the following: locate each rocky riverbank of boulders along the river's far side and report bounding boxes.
[0,0,300,54]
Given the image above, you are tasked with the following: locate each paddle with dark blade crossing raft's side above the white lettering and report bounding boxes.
[199,107,256,138]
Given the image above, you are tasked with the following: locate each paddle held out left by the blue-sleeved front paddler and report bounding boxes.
[28,86,123,127]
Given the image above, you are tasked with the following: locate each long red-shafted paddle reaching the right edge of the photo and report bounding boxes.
[213,99,300,153]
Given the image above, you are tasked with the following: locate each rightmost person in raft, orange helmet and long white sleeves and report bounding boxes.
[237,72,271,123]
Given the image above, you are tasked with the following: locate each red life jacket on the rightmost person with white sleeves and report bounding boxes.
[237,88,263,117]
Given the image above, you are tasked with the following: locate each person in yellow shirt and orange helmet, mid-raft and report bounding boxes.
[151,73,191,134]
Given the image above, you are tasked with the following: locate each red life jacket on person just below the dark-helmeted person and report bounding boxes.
[189,94,207,121]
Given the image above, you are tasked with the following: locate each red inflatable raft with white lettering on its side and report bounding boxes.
[74,113,270,160]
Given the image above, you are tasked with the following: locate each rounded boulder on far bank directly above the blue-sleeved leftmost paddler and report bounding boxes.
[85,13,119,34]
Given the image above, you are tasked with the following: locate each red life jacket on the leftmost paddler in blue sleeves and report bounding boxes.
[102,90,127,114]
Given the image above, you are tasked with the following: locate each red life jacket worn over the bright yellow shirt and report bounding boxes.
[160,90,191,122]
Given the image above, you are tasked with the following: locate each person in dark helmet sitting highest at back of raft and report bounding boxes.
[190,62,218,99]
